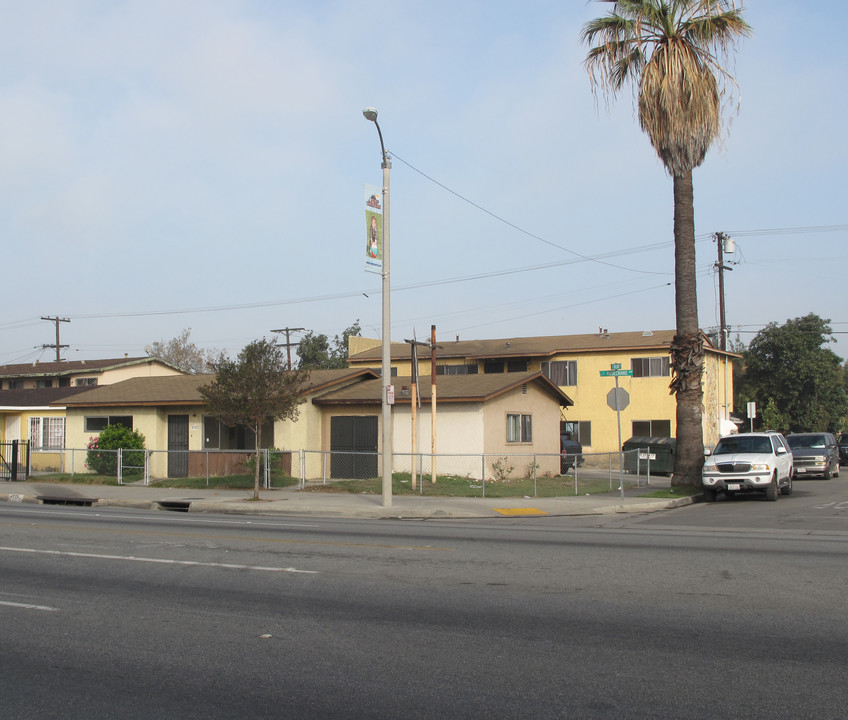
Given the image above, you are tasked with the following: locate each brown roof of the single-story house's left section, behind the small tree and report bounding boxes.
[53,368,377,407]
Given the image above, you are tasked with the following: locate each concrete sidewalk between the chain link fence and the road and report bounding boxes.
[0,478,699,519]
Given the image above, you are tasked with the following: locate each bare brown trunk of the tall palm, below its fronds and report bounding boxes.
[671,170,704,486]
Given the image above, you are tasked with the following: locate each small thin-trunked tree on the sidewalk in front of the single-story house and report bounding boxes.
[197,338,308,499]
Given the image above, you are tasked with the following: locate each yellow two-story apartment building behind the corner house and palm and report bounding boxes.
[348,330,738,452]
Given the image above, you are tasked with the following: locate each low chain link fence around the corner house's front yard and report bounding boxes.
[28,449,668,497]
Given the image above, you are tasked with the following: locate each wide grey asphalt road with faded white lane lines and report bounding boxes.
[0,480,848,720]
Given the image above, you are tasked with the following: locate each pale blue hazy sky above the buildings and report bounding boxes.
[0,0,848,364]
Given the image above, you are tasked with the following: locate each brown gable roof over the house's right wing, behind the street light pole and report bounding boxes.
[312,372,574,406]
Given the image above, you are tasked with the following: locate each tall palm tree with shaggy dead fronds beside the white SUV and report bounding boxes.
[582,0,751,485]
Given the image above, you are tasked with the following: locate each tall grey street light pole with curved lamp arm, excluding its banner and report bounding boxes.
[362,107,394,507]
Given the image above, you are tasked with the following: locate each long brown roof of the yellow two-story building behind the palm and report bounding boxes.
[350,330,721,363]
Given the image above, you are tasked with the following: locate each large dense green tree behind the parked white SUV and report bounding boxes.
[736,313,848,432]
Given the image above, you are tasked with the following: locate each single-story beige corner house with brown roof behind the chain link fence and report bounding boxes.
[51,368,571,477]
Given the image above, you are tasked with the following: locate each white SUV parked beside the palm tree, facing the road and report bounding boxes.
[701,432,795,502]
